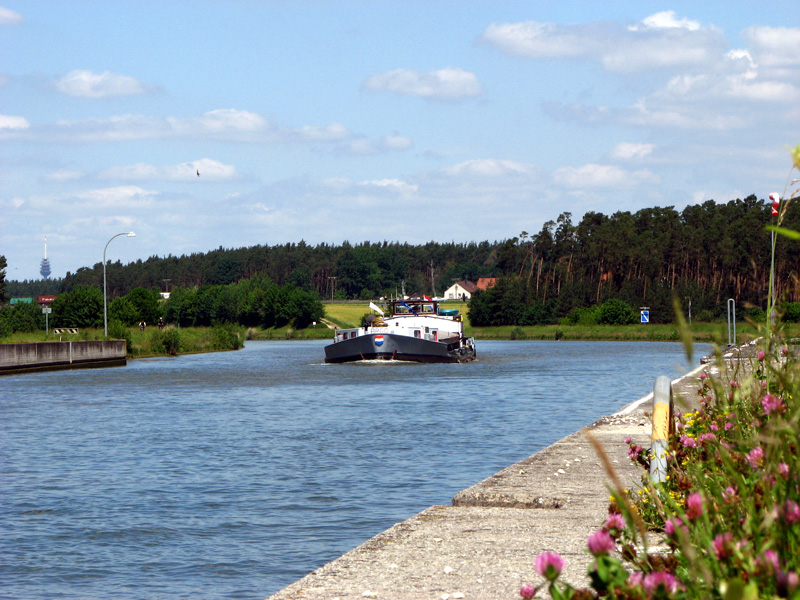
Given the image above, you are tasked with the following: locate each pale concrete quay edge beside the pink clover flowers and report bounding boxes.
[268,365,708,600]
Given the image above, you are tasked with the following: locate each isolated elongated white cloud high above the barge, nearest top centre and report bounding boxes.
[364,67,482,100]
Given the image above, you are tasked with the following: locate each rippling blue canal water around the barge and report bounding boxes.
[0,341,710,600]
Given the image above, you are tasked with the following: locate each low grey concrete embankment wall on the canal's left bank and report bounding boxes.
[0,340,126,375]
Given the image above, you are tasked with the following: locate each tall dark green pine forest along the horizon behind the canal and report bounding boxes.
[0,195,800,325]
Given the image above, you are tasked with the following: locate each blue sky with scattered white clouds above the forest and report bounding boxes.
[0,0,800,281]
